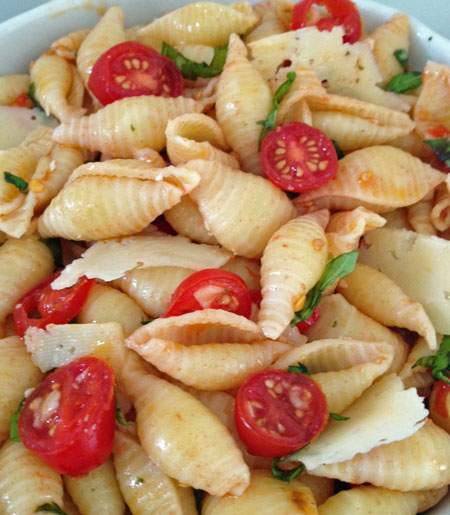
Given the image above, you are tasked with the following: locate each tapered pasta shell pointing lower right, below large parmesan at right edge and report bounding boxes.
[337,264,436,349]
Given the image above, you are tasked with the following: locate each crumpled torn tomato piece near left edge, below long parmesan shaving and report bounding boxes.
[13,272,95,338]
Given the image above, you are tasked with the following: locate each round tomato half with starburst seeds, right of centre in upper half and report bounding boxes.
[260,122,338,192]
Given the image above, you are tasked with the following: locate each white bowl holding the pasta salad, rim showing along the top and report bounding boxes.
[0,0,450,515]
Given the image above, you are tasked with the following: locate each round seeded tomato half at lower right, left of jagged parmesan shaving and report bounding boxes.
[234,370,328,457]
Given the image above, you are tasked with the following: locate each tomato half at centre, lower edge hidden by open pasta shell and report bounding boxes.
[161,269,252,318]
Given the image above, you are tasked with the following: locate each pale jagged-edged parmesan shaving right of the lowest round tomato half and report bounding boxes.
[289,374,428,470]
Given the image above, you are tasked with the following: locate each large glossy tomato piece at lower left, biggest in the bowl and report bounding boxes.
[19,356,115,476]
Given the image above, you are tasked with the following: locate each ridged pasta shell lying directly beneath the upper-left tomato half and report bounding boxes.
[53,95,202,158]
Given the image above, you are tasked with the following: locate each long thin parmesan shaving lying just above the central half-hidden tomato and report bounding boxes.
[52,236,232,290]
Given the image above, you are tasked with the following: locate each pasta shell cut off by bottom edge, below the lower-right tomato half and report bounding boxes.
[202,470,318,515]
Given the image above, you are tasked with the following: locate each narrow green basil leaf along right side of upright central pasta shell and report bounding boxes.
[291,250,358,327]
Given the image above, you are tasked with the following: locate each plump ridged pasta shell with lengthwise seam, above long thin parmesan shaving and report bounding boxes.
[38,159,200,240]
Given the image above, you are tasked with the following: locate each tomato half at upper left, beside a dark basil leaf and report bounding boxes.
[88,41,183,105]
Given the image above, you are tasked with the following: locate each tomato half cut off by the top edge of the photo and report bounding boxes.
[291,0,362,43]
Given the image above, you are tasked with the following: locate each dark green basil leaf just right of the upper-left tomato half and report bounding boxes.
[161,42,228,80]
